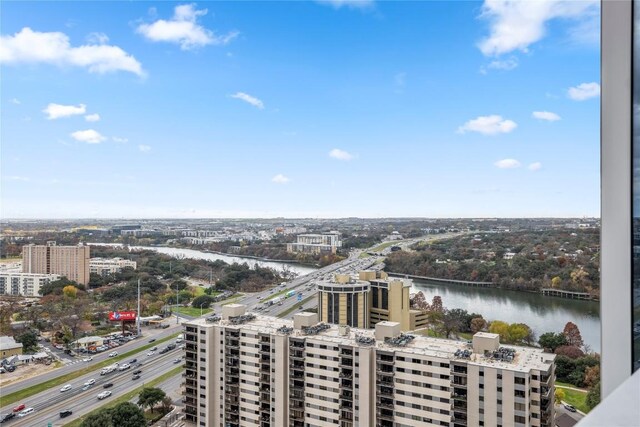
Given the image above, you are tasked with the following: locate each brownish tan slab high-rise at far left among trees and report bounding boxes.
[22,242,90,285]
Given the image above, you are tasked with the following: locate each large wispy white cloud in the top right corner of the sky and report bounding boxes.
[478,0,599,56]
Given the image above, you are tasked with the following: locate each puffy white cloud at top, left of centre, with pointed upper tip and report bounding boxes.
[136,4,240,50]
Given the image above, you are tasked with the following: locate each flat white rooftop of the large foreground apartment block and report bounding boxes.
[185,315,555,372]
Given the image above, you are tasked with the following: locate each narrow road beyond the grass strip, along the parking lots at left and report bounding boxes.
[0,320,182,398]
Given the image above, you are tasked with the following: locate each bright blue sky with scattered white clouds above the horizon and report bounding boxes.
[0,0,600,218]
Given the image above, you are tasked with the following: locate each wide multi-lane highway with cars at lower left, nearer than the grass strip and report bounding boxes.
[0,345,184,427]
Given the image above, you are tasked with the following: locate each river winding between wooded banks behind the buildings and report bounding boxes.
[91,243,600,352]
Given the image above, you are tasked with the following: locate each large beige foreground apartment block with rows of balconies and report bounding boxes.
[184,304,555,427]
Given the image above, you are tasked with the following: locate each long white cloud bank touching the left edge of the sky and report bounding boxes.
[0,27,144,76]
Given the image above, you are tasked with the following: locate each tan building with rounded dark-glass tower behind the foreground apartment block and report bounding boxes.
[317,270,428,331]
